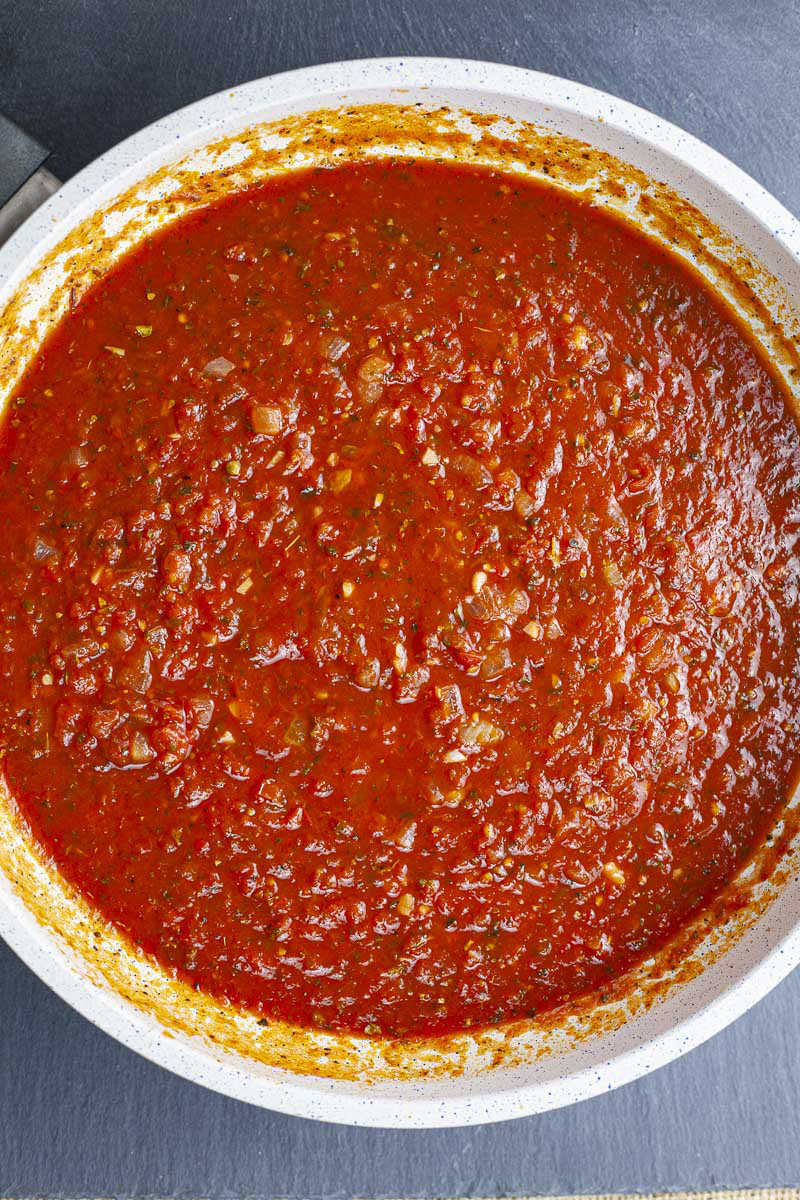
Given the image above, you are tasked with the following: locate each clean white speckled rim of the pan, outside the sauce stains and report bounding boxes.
[0,59,800,1128]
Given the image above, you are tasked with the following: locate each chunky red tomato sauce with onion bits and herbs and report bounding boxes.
[0,162,800,1036]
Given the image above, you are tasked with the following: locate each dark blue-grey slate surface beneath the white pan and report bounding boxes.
[0,0,800,1200]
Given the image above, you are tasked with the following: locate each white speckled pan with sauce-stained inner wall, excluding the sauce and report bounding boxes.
[0,59,800,1128]
